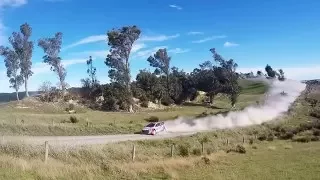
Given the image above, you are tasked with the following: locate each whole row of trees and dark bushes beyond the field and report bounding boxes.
[0,23,284,112]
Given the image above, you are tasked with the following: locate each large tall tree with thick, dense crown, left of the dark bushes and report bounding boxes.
[105,26,141,112]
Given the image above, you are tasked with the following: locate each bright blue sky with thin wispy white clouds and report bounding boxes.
[0,0,320,92]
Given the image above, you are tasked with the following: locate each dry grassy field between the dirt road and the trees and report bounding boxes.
[0,80,267,135]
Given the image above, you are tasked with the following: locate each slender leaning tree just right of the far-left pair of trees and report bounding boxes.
[38,32,67,95]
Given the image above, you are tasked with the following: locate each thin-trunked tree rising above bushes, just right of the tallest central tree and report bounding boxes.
[147,49,171,95]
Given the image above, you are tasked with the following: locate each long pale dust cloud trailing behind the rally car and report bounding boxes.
[165,79,306,133]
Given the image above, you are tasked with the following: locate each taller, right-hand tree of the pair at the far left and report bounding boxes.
[9,23,33,97]
